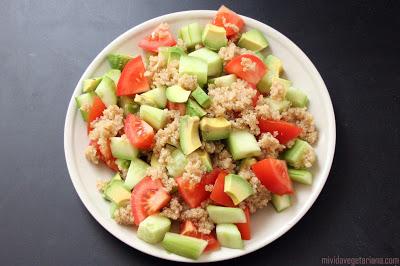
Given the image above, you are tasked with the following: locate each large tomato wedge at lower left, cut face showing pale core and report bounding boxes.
[131,176,171,225]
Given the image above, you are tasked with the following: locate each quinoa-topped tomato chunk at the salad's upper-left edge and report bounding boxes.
[139,24,176,53]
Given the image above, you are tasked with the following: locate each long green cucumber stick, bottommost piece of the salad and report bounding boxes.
[161,232,208,260]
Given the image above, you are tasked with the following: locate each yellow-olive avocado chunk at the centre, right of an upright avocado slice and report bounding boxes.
[200,117,231,140]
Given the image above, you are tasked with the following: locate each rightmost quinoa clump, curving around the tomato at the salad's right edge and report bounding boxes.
[282,107,318,144]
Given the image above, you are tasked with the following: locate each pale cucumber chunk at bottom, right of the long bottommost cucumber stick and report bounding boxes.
[215,224,244,249]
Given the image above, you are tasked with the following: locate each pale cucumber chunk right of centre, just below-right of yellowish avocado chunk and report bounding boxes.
[228,130,261,160]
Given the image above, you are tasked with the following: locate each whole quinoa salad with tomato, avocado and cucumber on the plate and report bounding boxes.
[76,6,318,259]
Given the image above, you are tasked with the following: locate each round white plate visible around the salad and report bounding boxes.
[64,10,336,262]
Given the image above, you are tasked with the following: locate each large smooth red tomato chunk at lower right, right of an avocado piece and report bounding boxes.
[251,158,293,195]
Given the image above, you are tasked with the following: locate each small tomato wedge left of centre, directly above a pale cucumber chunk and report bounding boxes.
[124,114,154,149]
